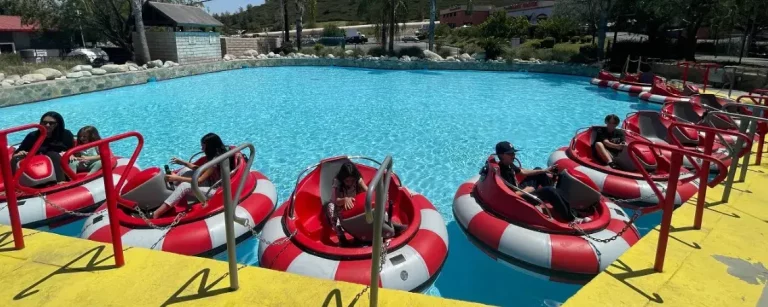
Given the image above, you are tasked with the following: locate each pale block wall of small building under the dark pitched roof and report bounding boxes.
[174,32,222,64]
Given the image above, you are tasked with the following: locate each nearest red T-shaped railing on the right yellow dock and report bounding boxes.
[627,141,727,272]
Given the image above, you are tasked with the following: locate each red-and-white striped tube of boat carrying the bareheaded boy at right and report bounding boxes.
[547,147,699,207]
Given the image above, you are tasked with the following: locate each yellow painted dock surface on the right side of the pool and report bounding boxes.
[565,154,768,307]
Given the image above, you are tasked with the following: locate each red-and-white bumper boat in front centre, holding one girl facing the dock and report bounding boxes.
[259,157,448,292]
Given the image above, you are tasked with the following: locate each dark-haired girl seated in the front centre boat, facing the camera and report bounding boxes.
[325,161,408,245]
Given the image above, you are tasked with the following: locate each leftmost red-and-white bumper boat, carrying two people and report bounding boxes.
[0,143,139,228]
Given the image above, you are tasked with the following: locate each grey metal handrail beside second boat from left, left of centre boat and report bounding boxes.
[192,143,256,290]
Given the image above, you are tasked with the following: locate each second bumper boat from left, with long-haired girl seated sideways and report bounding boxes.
[81,150,277,256]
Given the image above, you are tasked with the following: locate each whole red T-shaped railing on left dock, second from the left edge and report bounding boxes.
[61,131,144,267]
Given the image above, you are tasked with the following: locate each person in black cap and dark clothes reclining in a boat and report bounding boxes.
[496,141,590,223]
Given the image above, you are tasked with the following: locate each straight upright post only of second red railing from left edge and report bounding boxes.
[99,143,125,268]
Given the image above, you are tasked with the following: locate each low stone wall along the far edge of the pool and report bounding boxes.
[0,58,598,107]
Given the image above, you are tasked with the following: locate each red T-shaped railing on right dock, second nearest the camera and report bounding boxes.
[667,122,752,229]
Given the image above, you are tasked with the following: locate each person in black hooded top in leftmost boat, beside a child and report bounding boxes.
[11,111,75,183]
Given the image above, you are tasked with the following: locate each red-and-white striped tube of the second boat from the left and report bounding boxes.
[81,171,277,256]
